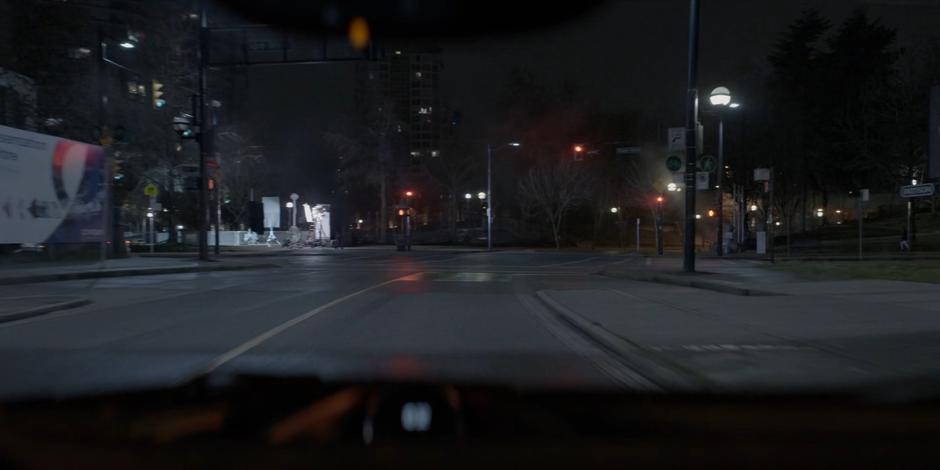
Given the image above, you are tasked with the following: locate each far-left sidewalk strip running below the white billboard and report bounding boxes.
[0,254,278,285]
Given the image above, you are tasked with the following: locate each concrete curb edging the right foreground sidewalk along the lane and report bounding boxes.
[535,290,710,391]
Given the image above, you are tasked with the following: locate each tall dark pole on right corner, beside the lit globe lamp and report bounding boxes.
[682,0,699,273]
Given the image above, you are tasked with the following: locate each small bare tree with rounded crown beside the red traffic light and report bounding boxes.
[519,160,590,249]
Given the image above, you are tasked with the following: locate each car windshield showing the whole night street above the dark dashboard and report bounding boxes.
[0,0,940,401]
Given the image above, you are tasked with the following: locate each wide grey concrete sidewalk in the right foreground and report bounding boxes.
[538,281,940,393]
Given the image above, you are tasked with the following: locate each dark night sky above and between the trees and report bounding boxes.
[237,0,940,199]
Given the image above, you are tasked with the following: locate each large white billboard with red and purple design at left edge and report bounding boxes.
[0,126,108,243]
